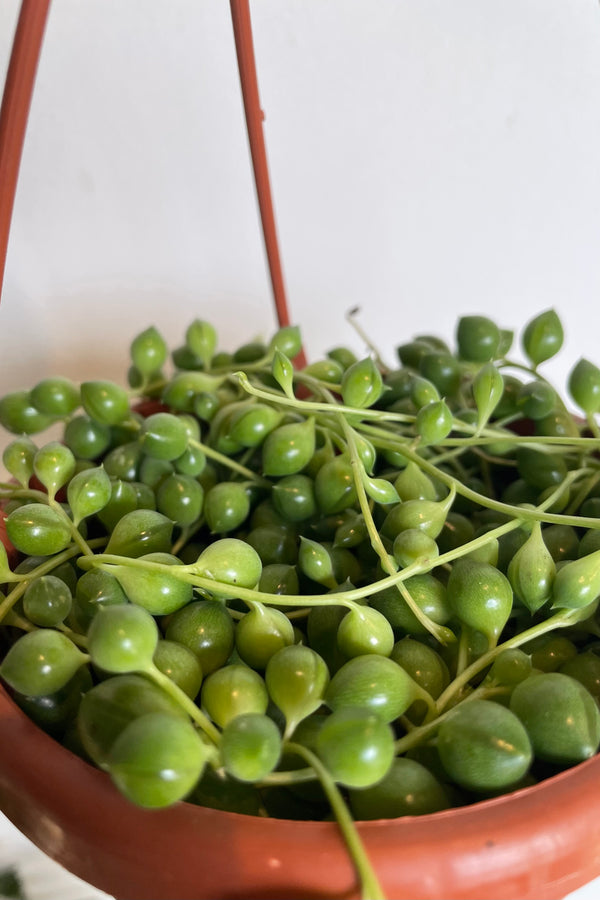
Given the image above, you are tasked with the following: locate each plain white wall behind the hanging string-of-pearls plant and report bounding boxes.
[0,0,600,400]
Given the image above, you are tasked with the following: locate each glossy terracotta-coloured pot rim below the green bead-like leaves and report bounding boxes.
[0,688,600,900]
